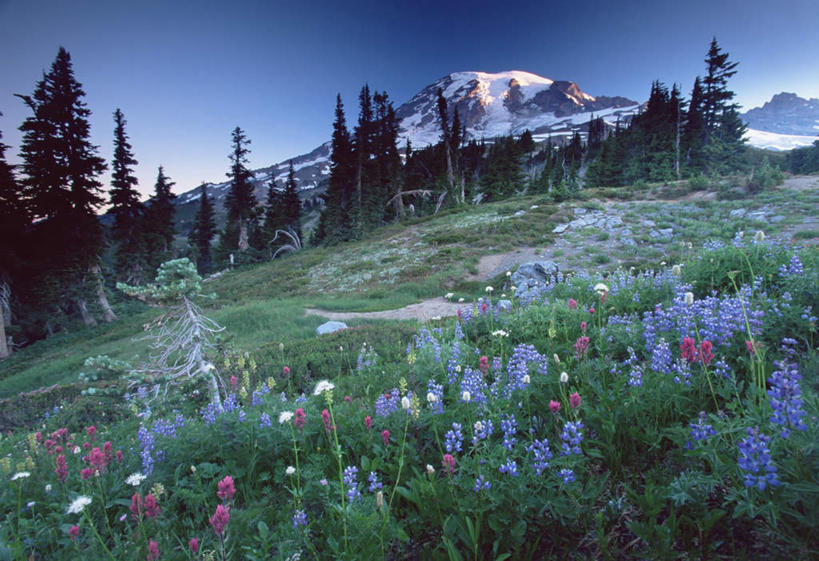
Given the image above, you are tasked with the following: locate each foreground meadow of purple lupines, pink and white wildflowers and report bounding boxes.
[0,236,819,561]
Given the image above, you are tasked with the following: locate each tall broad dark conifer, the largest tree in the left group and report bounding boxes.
[19,47,116,329]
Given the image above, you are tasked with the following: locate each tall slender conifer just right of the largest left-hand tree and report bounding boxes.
[110,109,144,282]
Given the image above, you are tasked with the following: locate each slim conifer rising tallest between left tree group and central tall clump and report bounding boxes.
[225,127,256,251]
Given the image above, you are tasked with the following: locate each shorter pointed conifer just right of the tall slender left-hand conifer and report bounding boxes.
[141,166,176,276]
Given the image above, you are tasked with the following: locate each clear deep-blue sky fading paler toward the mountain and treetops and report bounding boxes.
[0,0,819,199]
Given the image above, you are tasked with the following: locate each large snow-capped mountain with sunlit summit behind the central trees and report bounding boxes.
[176,71,639,217]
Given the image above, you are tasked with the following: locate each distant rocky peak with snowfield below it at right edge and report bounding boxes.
[741,92,819,150]
